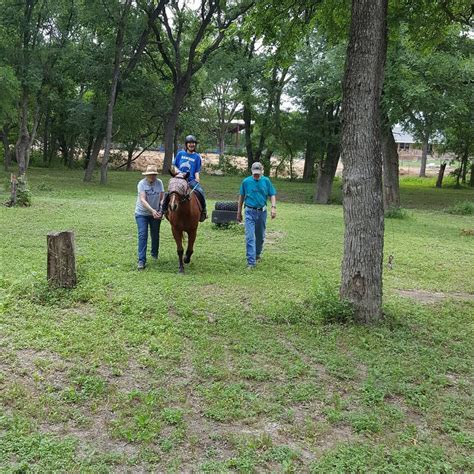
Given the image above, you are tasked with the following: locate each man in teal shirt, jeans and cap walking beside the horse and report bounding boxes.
[237,162,276,269]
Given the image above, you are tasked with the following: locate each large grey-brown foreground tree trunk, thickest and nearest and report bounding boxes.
[340,0,388,323]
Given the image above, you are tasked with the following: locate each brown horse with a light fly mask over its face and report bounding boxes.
[167,174,201,273]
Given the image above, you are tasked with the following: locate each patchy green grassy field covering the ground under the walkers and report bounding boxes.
[0,169,474,473]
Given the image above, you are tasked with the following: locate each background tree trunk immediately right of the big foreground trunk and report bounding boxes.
[382,124,400,209]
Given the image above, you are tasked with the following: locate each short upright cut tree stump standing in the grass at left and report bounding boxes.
[47,231,77,288]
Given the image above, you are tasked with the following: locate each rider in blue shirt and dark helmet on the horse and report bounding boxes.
[161,135,207,222]
